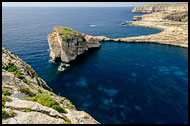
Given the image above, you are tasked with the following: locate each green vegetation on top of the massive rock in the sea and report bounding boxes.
[56,26,80,40]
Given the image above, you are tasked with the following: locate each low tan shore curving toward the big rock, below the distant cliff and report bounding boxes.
[93,12,188,48]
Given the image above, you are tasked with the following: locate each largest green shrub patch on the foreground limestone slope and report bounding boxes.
[25,93,67,113]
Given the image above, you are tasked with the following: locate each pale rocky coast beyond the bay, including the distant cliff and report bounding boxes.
[94,4,188,48]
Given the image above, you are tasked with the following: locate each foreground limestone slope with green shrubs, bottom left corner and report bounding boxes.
[2,48,99,124]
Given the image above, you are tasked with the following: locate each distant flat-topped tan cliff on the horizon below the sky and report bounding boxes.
[132,3,188,13]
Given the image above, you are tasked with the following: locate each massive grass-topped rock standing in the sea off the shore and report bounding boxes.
[48,26,100,63]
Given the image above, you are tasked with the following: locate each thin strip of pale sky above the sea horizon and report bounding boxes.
[2,2,187,7]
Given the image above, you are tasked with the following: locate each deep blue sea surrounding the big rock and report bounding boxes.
[2,7,188,124]
